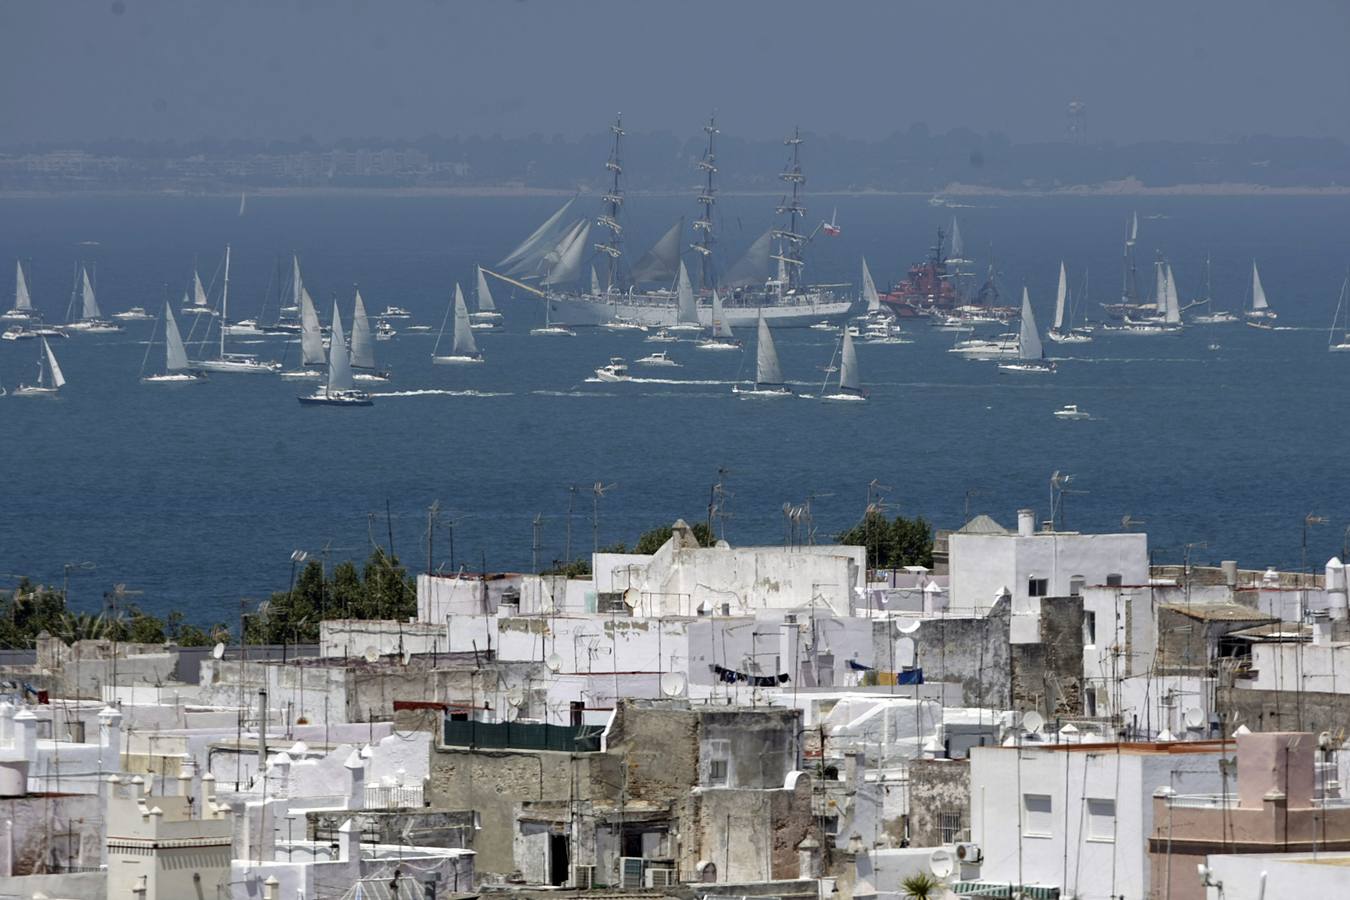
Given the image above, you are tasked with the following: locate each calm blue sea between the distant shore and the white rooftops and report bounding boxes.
[0,196,1350,621]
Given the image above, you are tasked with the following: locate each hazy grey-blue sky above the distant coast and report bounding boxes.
[0,0,1350,143]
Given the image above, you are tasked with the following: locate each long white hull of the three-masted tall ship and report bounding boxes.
[549,291,853,331]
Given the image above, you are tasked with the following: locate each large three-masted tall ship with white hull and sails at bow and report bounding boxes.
[487,117,852,328]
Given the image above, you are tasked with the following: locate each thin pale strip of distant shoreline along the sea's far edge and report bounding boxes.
[0,178,1350,200]
